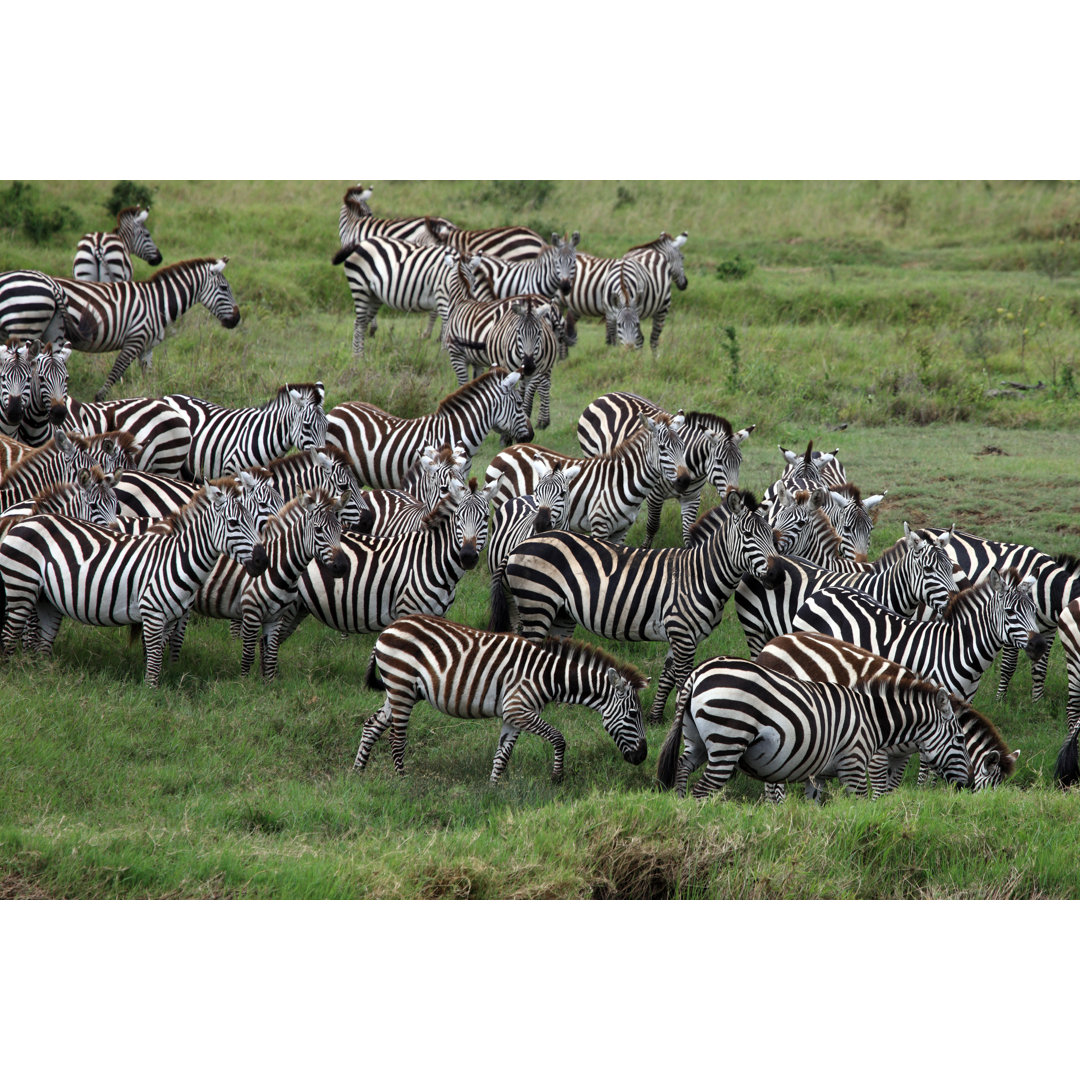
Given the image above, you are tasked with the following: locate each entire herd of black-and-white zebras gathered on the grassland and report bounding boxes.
[0,185,1080,801]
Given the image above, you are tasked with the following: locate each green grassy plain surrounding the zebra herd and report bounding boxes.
[0,178,1080,899]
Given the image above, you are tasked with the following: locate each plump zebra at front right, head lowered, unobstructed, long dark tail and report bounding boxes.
[657,657,971,799]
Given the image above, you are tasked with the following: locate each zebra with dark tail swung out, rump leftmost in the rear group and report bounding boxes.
[330,235,457,356]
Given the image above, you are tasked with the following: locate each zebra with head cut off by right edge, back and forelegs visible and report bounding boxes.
[921,526,1080,701]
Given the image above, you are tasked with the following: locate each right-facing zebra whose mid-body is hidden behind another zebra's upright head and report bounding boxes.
[484,413,690,543]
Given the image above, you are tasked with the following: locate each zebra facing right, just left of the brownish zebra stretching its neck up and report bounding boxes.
[162,382,326,480]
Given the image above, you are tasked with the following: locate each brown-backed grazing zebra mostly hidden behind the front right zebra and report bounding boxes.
[756,633,1020,802]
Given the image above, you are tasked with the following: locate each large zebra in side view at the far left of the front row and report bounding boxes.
[0,480,266,687]
